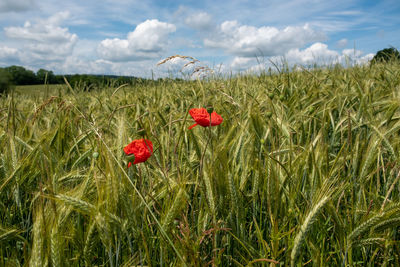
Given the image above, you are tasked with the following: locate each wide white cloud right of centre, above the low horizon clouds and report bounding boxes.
[204,21,325,57]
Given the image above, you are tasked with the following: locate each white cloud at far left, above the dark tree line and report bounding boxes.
[4,12,78,63]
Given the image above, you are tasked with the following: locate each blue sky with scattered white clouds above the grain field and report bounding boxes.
[0,0,400,77]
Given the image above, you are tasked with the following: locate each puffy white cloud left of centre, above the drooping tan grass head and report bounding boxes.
[97,19,176,62]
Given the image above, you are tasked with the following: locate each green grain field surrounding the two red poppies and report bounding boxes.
[0,63,400,266]
